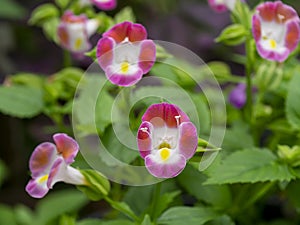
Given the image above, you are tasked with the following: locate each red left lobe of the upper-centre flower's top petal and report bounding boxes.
[103,21,132,43]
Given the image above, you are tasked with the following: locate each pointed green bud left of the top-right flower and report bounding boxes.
[216,24,248,46]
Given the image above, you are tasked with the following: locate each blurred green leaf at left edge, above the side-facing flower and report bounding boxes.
[0,86,43,118]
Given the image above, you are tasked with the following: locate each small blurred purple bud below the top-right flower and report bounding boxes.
[229,83,247,109]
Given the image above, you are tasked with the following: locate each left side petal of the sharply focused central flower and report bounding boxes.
[137,121,153,158]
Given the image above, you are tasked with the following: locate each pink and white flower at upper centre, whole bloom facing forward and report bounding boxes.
[97,21,156,86]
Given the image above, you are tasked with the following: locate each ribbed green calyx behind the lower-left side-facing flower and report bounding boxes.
[77,170,110,201]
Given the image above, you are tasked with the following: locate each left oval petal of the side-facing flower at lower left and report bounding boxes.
[29,142,57,178]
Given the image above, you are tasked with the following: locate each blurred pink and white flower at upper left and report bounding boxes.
[57,11,98,53]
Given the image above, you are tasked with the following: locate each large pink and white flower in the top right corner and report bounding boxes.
[252,1,300,62]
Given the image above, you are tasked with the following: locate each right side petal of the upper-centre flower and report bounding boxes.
[139,40,156,74]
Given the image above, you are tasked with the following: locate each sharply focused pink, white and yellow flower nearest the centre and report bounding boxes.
[137,103,198,178]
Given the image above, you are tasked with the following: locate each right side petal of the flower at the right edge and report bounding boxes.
[285,20,300,52]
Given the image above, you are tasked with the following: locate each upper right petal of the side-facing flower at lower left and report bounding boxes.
[53,133,79,164]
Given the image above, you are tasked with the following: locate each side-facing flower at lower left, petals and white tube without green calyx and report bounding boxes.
[26,134,86,198]
